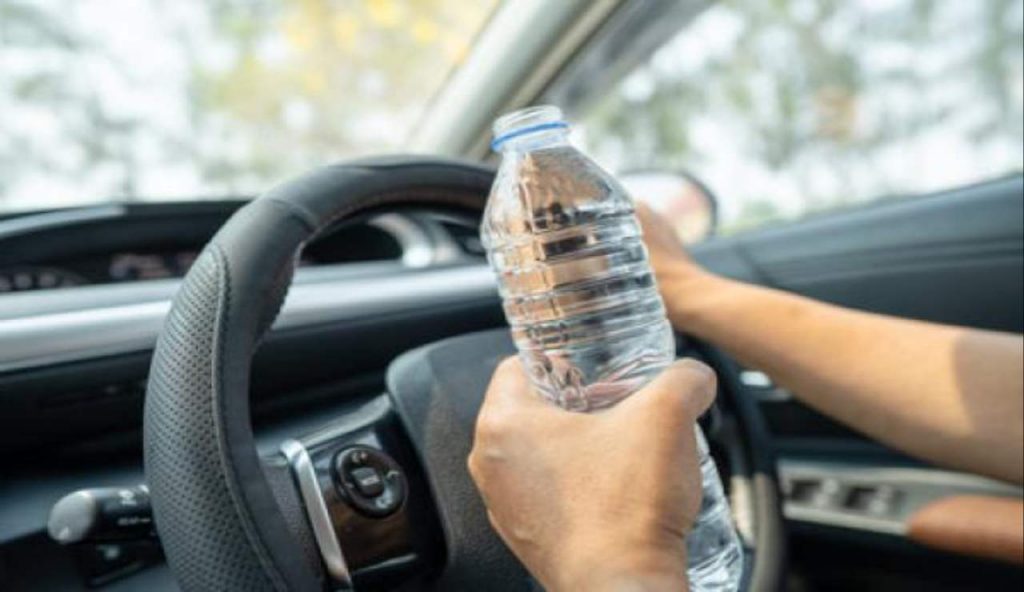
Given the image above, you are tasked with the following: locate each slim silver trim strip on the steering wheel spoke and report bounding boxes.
[281,439,352,590]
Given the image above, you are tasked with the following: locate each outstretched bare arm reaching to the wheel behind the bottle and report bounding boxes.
[639,208,1024,483]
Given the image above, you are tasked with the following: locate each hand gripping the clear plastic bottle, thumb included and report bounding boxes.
[469,358,716,592]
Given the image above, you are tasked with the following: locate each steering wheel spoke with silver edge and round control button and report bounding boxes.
[281,389,442,589]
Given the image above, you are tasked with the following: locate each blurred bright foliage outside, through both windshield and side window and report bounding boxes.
[0,0,1024,221]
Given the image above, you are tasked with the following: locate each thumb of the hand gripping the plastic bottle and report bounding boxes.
[614,358,718,427]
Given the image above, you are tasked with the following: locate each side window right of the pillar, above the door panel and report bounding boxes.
[574,0,1024,234]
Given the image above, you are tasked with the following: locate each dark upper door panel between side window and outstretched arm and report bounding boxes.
[693,176,1024,333]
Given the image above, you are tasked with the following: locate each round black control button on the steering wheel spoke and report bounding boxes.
[334,446,406,518]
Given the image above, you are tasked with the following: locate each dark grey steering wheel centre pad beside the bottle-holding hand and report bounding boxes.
[387,328,540,592]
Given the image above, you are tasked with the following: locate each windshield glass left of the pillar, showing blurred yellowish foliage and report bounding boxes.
[0,0,498,212]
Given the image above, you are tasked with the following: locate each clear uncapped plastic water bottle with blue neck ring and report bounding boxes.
[481,107,742,591]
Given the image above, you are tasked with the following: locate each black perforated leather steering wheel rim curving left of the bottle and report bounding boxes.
[143,158,494,591]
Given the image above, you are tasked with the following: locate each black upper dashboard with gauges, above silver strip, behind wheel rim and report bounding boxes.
[0,201,482,294]
